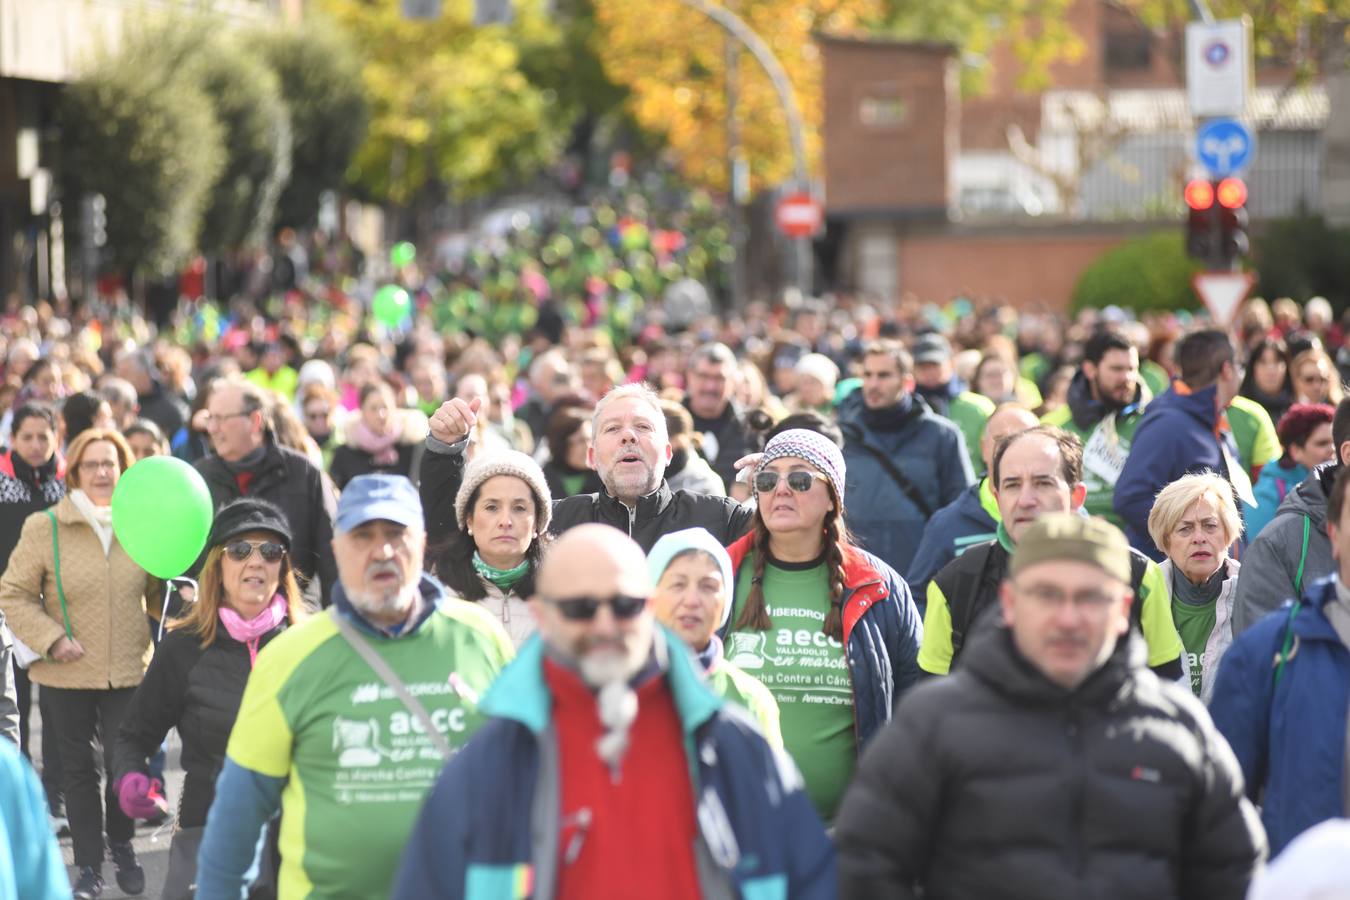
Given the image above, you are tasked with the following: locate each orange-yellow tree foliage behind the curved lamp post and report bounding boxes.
[594,0,884,190]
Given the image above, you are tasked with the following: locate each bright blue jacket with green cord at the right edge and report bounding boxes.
[1210,575,1350,858]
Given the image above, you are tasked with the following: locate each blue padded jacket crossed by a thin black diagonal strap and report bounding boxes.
[838,390,975,572]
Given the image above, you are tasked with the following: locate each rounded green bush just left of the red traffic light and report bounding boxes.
[1072,231,1200,313]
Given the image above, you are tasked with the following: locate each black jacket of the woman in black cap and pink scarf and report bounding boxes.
[113,622,286,828]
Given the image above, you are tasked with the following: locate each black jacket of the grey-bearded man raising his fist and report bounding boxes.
[419,445,755,552]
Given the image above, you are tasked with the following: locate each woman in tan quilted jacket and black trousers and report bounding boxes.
[0,428,161,897]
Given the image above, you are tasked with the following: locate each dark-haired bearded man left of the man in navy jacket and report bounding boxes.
[1041,331,1153,528]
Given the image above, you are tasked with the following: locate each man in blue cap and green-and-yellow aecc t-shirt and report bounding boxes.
[197,475,512,900]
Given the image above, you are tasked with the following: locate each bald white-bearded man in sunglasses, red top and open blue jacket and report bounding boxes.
[393,524,834,900]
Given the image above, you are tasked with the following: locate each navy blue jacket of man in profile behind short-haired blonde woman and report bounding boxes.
[1115,385,1238,563]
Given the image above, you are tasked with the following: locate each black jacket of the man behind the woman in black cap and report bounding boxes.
[196,443,337,606]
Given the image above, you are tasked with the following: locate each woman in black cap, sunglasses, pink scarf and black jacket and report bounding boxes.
[113,498,304,900]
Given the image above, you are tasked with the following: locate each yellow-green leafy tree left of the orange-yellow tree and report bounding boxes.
[320,0,570,204]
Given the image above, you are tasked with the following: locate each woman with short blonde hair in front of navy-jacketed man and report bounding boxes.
[1149,472,1242,703]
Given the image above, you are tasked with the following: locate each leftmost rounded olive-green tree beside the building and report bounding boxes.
[61,33,224,273]
